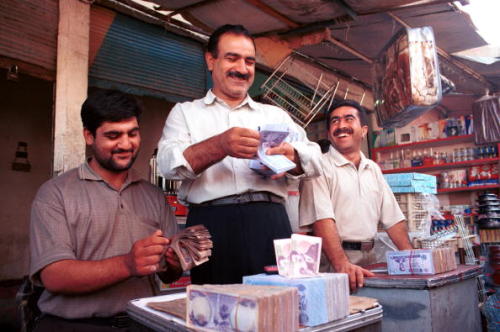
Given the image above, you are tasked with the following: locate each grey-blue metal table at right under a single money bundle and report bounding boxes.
[356,264,482,332]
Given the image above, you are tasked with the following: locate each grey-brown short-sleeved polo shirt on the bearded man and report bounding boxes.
[30,163,177,318]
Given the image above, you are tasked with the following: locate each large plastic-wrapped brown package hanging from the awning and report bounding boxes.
[373,27,442,128]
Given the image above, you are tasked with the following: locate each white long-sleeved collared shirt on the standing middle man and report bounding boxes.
[158,91,320,204]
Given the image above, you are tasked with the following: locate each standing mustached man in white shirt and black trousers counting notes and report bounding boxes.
[158,25,320,284]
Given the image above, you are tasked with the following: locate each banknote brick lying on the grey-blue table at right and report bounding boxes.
[386,248,457,275]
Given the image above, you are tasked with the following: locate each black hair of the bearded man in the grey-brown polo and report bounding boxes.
[80,90,142,136]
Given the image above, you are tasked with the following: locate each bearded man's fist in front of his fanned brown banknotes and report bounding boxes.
[125,230,170,277]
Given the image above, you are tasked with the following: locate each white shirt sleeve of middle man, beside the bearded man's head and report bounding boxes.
[157,103,198,180]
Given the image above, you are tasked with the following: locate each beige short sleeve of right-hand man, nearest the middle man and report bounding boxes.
[299,161,335,229]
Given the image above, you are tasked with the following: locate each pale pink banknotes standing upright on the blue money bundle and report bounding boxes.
[274,234,322,278]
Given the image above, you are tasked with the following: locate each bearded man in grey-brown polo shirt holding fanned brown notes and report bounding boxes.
[30,90,181,332]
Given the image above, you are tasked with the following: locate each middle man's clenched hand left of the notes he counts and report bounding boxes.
[219,127,260,159]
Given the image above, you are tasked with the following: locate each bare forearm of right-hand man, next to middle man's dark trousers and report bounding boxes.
[313,219,349,267]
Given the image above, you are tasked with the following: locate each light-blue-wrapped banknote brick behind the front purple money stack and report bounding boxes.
[243,273,349,326]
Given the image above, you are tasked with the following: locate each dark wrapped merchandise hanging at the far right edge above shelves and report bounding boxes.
[472,95,500,144]
